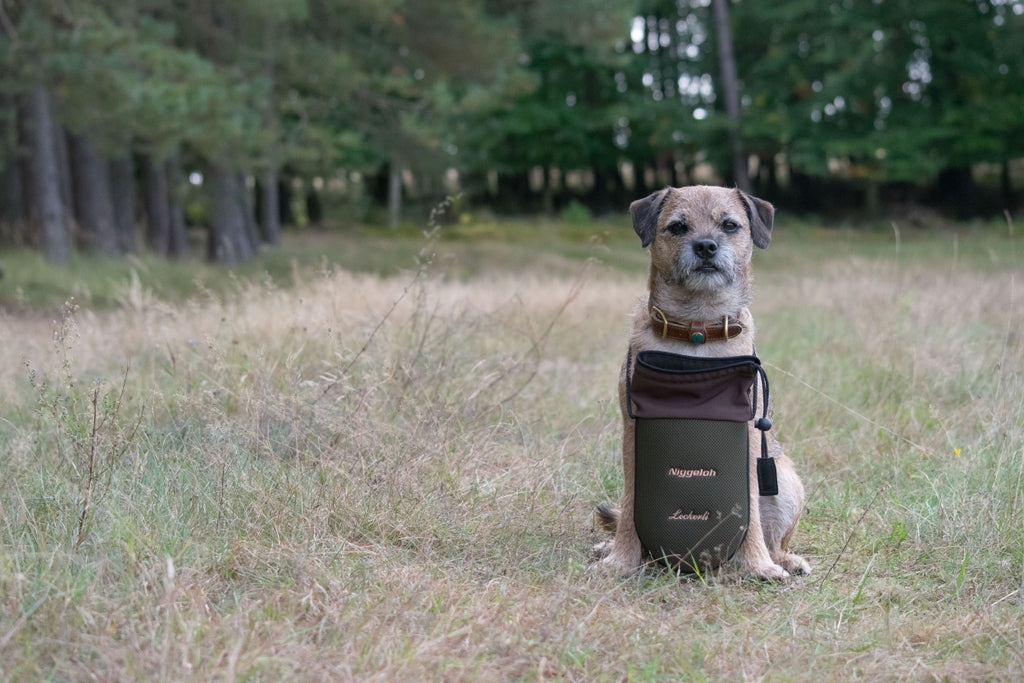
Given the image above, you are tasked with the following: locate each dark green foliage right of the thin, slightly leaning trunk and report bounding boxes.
[734,1,1024,182]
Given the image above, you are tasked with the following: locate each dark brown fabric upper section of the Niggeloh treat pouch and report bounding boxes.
[628,351,761,422]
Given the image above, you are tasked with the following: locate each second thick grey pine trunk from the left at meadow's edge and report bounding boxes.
[71,133,121,256]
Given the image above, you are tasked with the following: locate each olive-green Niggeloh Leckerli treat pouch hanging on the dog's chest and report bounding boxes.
[627,351,774,571]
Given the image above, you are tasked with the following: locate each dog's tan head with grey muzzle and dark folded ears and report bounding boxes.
[630,186,775,292]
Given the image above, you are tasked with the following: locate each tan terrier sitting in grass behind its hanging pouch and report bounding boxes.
[595,186,811,581]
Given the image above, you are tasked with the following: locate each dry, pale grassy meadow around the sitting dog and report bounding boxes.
[0,221,1024,681]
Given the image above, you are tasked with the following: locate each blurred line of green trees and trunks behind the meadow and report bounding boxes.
[0,0,1024,263]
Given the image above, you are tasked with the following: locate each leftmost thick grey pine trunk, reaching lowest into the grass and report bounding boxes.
[26,85,72,263]
